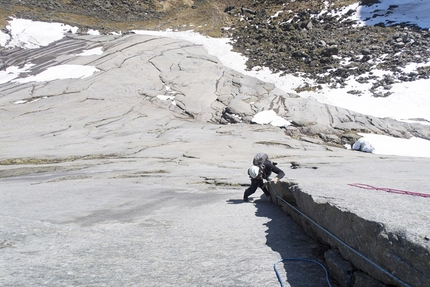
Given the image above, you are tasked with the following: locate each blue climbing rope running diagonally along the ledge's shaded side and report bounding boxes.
[269,181,412,287]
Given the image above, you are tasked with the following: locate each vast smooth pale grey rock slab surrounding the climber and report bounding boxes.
[0,32,430,286]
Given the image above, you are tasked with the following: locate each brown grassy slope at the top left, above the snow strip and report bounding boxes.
[0,0,242,37]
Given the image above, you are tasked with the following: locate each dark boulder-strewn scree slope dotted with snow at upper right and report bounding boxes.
[225,1,430,97]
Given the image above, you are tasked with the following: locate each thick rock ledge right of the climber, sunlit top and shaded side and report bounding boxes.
[271,158,430,287]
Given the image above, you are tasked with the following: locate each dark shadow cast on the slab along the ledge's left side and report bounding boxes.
[254,195,335,287]
